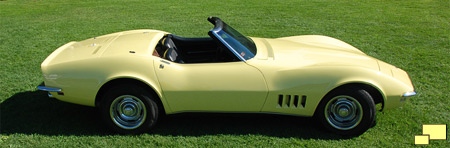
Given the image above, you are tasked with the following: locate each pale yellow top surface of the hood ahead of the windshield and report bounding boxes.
[249,35,379,70]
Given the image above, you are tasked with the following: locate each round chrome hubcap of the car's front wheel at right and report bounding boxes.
[325,96,363,130]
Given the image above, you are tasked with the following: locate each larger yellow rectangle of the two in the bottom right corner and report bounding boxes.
[422,124,447,140]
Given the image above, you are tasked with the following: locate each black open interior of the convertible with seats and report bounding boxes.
[153,34,240,63]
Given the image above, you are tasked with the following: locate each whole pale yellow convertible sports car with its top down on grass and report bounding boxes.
[38,17,416,136]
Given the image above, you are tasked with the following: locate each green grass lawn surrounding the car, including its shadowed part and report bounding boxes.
[0,0,450,147]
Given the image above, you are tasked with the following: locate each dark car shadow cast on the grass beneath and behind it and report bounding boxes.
[0,91,346,139]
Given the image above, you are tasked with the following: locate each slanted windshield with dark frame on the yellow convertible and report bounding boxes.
[209,18,256,61]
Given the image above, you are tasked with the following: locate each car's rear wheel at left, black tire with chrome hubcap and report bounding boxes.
[99,84,159,135]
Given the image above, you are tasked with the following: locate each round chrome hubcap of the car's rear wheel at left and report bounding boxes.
[109,95,147,129]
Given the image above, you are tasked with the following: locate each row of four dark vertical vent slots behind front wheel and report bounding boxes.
[278,94,306,108]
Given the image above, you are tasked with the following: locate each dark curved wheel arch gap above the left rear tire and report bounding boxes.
[95,77,166,114]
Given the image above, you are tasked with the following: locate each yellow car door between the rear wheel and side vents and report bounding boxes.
[154,58,268,112]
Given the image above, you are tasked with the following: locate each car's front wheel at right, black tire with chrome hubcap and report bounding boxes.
[315,87,376,136]
